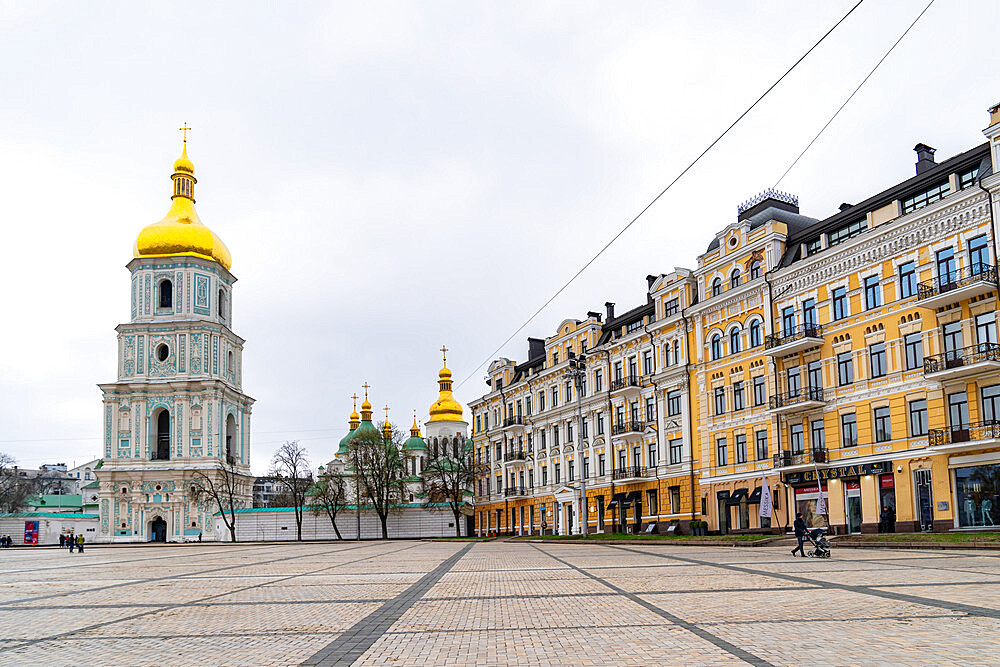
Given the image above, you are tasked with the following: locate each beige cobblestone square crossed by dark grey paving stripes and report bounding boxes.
[0,541,1000,666]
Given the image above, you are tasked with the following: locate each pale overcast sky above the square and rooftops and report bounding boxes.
[0,0,1000,478]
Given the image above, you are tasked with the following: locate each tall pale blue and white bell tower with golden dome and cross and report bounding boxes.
[97,134,253,542]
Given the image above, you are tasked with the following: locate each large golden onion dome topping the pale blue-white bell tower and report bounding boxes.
[132,142,233,271]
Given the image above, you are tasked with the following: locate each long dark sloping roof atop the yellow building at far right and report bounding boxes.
[781,143,990,266]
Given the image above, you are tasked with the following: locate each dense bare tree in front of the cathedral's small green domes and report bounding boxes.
[348,428,407,540]
